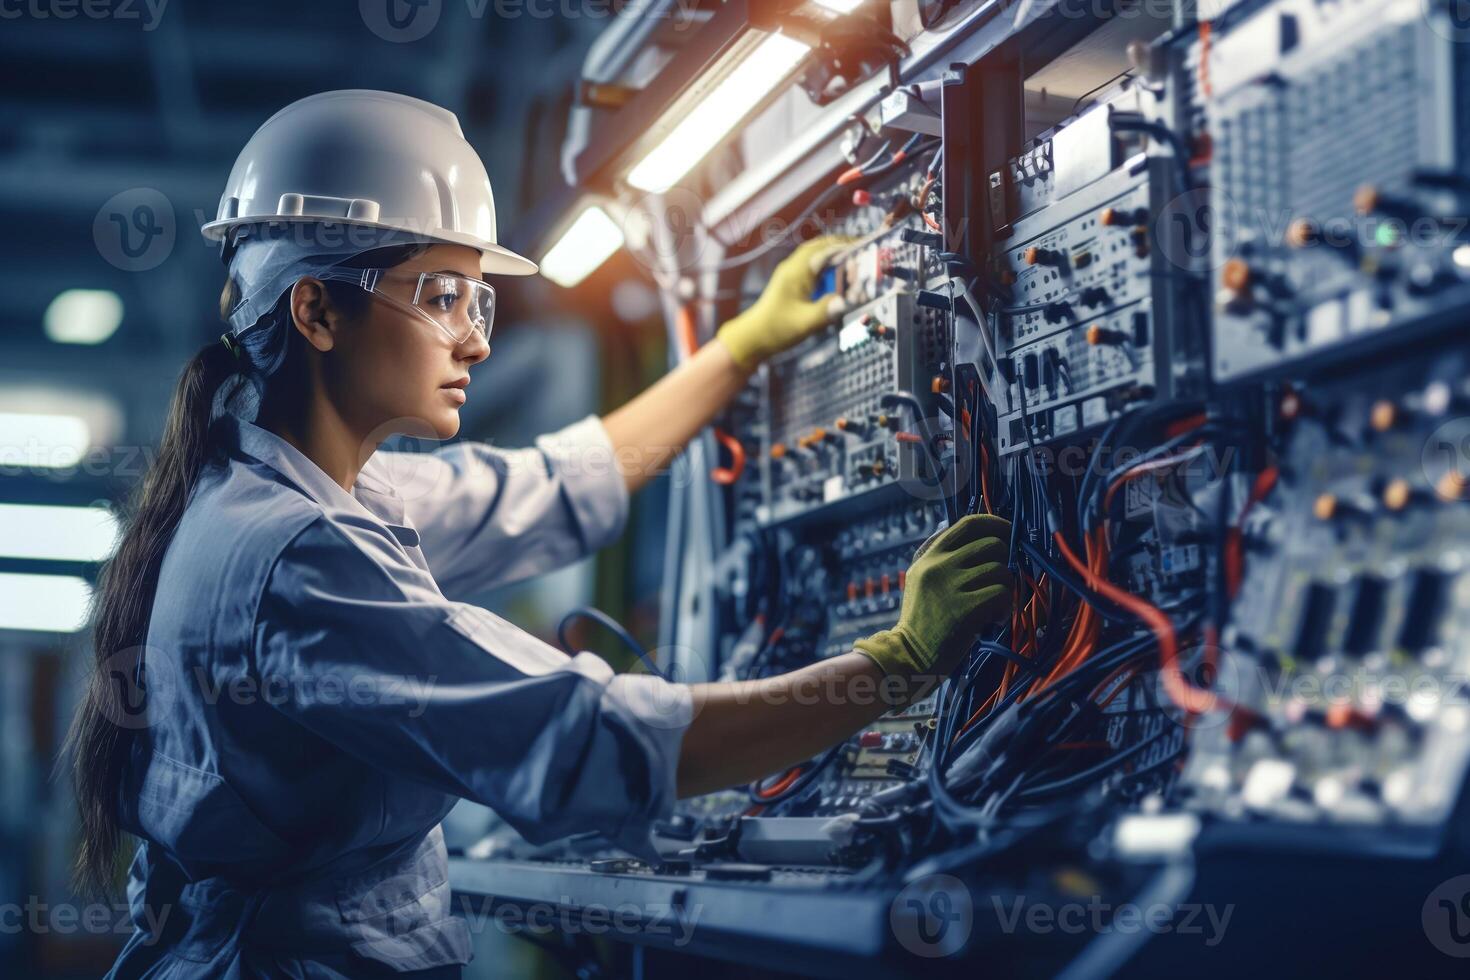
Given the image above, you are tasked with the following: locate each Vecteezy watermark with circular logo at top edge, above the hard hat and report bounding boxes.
[357,0,697,44]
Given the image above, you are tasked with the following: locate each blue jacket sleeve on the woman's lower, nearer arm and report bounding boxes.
[253,517,692,857]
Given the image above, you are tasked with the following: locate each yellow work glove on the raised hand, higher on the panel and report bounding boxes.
[716,235,857,370]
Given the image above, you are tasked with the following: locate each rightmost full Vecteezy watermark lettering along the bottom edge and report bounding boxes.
[991,895,1235,946]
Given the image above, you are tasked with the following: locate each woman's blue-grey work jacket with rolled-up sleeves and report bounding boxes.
[112,416,691,977]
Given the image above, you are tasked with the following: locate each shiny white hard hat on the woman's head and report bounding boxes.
[203,88,537,276]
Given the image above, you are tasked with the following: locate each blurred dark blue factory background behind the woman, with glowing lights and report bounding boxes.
[0,0,664,977]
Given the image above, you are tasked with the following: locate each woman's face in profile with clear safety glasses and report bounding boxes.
[322,245,490,439]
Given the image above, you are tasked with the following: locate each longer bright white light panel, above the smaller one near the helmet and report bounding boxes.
[628,34,811,194]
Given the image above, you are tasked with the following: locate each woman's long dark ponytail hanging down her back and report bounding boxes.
[68,341,241,893]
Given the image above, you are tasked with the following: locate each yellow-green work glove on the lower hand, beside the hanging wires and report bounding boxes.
[853,514,1011,676]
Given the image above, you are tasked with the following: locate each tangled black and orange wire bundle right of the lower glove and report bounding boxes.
[905,399,1273,840]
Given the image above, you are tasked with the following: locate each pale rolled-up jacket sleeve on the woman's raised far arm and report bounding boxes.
[365,416,628,597]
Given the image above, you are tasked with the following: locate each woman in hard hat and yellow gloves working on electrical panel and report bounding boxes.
[72,91,1008,977]
